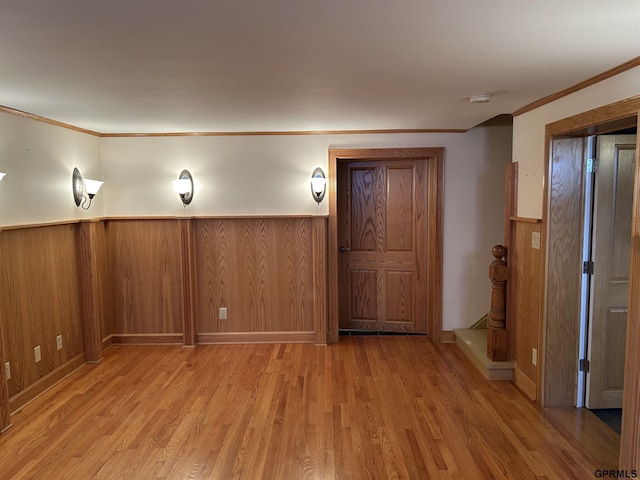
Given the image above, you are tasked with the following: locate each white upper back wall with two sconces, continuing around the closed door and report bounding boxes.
[101,127,511,330]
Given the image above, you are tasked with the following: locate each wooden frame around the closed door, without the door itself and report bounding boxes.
[327,147,444,343]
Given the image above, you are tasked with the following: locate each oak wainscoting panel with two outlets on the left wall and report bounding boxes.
[0,224,85,402]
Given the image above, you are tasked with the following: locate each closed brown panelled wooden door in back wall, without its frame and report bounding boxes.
[337,159,428,333]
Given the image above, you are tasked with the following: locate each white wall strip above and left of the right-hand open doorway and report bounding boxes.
[513,67,640,218]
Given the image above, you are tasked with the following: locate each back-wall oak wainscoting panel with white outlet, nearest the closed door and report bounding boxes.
[194,218,314,341]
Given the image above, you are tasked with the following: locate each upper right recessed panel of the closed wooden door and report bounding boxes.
[385,168,415,252]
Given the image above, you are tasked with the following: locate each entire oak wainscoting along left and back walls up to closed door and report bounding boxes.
[0,216,327,418]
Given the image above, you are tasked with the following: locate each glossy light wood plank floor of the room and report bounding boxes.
[0,336,619,480]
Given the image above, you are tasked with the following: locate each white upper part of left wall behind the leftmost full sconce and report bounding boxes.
[0,112,103,226]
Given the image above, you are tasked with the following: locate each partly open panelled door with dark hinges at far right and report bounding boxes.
[586,135,636,408]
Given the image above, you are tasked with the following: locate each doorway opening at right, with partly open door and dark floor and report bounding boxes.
[576,127,637,434]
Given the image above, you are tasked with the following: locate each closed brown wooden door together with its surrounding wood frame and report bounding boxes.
[328,148,444,342]
